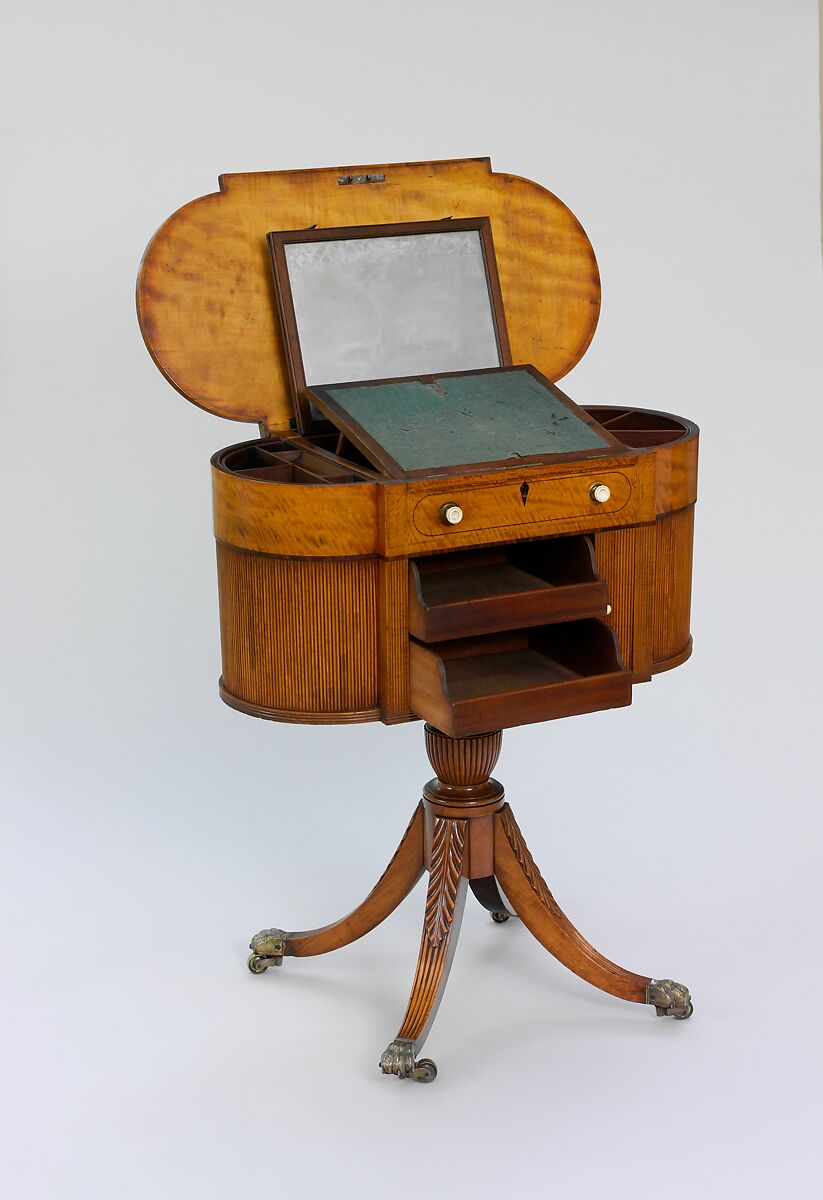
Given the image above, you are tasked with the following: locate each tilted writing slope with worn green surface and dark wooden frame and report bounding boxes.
[313,367,609,472]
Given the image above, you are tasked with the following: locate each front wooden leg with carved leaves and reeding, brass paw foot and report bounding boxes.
[380,817,468,1082]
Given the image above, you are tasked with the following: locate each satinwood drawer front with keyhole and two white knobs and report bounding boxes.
[412,466,644,541]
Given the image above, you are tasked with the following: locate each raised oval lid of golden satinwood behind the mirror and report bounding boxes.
[137,158,600,431]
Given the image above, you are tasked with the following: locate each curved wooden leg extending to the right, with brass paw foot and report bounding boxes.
[494,805,692,1020]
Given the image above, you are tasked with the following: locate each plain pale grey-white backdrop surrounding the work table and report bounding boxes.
[0,0,823,1200]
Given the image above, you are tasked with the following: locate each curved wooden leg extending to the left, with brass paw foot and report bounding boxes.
[248,804,425,974]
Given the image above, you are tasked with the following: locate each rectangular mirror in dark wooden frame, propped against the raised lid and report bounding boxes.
[269,217,511,432]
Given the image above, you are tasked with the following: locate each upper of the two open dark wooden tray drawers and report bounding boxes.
[409,536,607,642]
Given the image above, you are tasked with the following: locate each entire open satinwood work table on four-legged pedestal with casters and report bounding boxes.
[137,158,698,1081]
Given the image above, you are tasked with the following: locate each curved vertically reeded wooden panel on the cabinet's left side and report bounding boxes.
[217,542,379,724]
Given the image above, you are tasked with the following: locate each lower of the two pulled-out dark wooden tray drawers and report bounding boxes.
[410,620,631,737]
